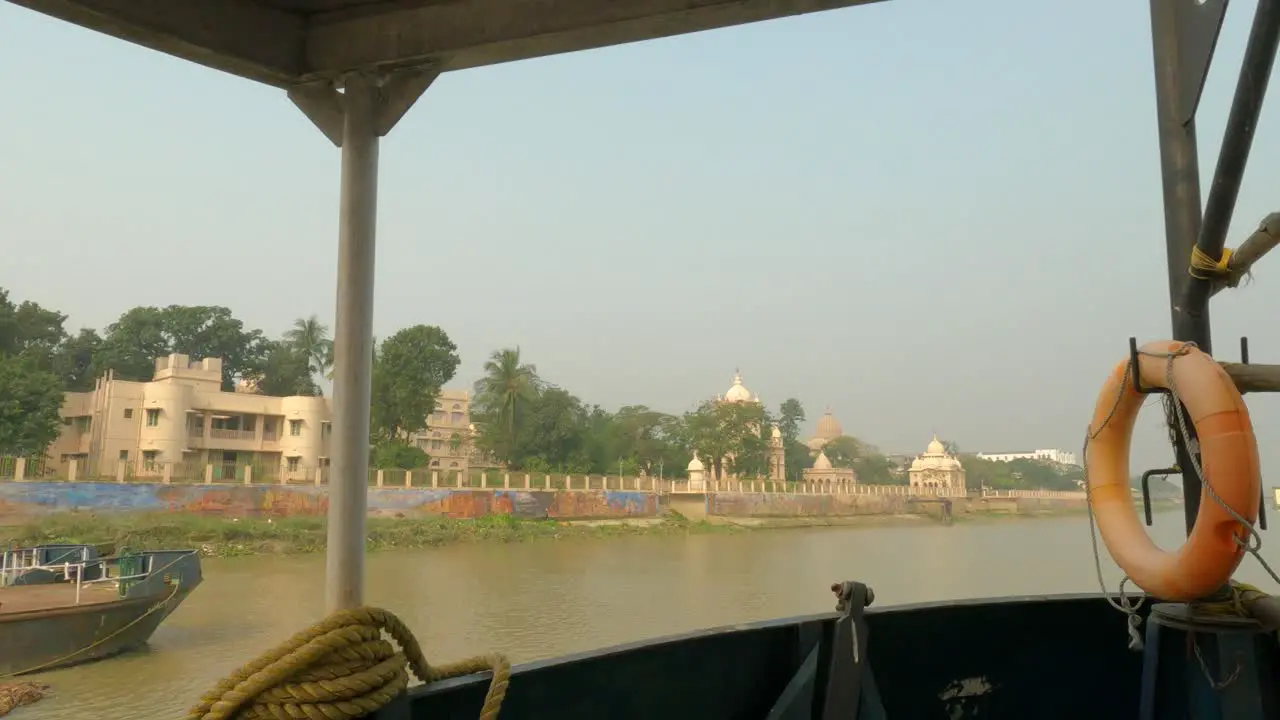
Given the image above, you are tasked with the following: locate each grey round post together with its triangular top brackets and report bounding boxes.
[289,68,436,612]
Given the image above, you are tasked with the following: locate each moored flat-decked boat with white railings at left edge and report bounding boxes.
[0,544,201,678]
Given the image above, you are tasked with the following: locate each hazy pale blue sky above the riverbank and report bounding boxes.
[0,0,1280,471]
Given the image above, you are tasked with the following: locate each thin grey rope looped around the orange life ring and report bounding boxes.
[1080,342,1280,650]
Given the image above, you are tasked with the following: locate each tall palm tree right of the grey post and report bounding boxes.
[472,347,540,465]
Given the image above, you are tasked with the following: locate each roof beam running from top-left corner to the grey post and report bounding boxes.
[9,0,306,87]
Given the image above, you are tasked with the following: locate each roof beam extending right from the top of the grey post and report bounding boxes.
[307,0,876,77]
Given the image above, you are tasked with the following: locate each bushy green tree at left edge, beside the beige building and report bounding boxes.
[0,354,63,456]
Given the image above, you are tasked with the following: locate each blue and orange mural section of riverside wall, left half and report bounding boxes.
[0,482,658,523]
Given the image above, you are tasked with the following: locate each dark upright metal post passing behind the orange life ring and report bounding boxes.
[1151,0,1212,533]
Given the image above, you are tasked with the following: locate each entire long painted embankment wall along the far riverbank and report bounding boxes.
[0,482,1085,524]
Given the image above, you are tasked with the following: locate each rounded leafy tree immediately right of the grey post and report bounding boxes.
[371,325,461,442]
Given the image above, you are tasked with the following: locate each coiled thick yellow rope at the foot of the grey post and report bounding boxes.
[187,607,511,720]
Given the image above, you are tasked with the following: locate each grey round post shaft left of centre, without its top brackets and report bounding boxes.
[325,74,378,612]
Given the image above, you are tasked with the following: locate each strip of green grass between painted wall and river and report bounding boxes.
[0,512,735,557]
